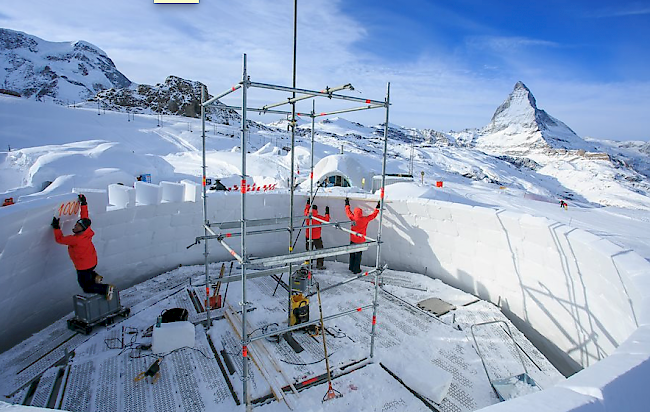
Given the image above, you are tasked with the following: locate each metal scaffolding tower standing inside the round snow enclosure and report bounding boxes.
[196,54,390,406]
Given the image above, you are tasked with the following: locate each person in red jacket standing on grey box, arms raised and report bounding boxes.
[52,195,114,300]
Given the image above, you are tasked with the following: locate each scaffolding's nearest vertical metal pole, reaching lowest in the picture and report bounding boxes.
[240,54,250,407]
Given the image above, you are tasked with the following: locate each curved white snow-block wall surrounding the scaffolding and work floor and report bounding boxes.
[0,188,650,412]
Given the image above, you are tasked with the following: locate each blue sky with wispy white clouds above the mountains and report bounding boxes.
[0,0,650,140]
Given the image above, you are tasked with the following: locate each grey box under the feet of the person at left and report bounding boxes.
[68,290,130,334]
